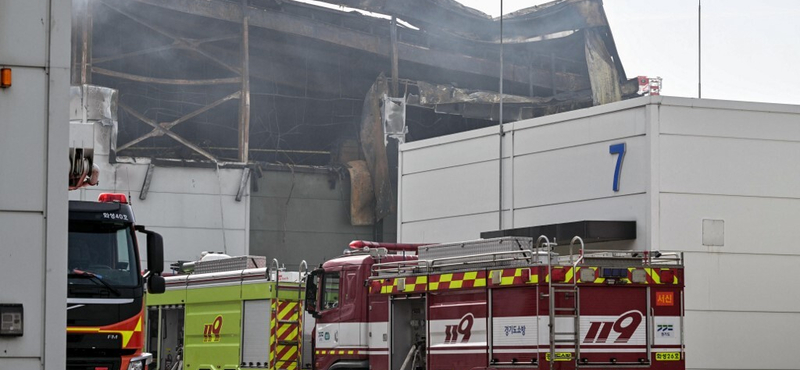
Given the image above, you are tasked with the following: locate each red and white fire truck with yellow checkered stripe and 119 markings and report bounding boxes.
[306,236,685,370]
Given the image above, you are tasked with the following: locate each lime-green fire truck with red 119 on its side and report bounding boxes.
[146,254,313,370]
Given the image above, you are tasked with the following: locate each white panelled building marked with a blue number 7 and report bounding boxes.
[398,97,800,369]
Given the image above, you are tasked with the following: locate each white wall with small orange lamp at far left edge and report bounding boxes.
[0,0,71,370]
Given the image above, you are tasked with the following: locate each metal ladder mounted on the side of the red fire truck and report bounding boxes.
[536,235,583,370]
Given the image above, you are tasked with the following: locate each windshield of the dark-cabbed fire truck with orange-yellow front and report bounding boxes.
[67,222,139,287]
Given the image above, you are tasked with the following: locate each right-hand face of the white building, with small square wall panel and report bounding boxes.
[657,99,800,369]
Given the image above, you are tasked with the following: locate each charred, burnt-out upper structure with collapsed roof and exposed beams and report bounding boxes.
[72,0,637,166]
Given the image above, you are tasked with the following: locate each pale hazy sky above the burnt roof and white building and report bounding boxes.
[457,0,800,104]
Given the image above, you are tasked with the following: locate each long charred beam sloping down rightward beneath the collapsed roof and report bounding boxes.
[122,0,589,91]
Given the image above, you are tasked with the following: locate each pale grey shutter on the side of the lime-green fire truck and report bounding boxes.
[242,299,272,366]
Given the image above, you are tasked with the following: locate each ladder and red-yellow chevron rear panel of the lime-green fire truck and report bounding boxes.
[270,258,308,370]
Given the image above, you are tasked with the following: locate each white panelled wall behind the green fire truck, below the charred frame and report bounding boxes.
[70,126,250,272]
